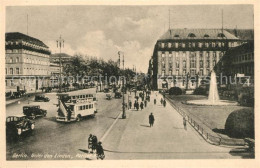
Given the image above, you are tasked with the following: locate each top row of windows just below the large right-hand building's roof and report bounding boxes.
[159,42,232,48]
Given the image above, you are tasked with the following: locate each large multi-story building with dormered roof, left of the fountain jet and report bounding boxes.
[149,29,243,90]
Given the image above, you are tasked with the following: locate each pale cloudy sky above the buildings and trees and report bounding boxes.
[6,5,254,72]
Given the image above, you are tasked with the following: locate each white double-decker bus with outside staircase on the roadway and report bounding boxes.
[56,89,97,122]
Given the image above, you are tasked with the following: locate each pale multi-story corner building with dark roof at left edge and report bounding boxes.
[5,32,51,91]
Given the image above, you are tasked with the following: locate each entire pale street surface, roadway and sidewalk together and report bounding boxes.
[6,90,250,160]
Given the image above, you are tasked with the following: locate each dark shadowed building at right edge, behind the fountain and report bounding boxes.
[214,41,254,89]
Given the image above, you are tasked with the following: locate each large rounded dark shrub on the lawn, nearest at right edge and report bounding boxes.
[225,108,255,138]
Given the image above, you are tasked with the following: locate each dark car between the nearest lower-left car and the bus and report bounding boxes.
[23,105,47,119]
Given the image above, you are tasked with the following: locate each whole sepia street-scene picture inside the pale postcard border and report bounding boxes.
[1,0,256,165]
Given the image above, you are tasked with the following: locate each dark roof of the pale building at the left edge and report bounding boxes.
[5,32,49,48]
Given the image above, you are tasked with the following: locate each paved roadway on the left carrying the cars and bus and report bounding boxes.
[6,90,122,160]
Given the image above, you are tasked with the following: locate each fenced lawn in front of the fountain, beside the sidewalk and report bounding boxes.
[166,95,254,139]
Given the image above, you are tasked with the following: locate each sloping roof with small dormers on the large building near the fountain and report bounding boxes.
[159,28,238,40]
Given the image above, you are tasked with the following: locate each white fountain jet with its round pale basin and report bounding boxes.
[186,71,237,106]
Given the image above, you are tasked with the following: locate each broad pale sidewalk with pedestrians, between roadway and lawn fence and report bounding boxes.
[103,94,242,159]
